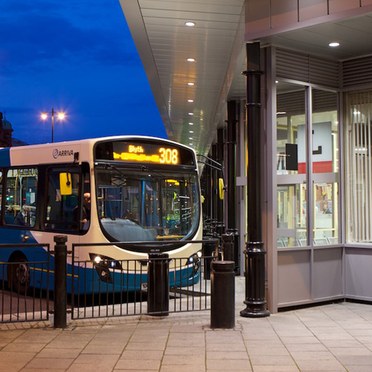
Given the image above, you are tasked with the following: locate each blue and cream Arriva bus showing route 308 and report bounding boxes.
[0,136,202,292]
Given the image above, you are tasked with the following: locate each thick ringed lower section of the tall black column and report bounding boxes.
[240,242,270,318]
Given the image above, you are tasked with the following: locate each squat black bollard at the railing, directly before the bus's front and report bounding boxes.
[147,253,169,316]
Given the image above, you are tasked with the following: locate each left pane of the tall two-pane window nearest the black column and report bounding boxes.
[277,83,307,247]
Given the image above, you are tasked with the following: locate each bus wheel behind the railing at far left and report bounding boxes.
[8,255,30,294]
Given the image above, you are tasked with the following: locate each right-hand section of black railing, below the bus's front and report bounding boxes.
[71,240,219,319]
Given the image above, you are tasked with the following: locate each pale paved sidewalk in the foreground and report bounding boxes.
[0,280,372,372]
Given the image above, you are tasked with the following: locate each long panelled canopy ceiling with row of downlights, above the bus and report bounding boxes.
[120,0,244,153]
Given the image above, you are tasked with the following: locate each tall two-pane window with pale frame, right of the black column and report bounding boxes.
[276,82,339,248]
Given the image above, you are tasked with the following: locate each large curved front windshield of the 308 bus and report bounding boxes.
[96,165,200,242]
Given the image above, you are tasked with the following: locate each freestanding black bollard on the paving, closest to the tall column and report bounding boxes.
[211,261,235,328]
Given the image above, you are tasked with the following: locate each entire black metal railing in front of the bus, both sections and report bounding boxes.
[0,236,227,322]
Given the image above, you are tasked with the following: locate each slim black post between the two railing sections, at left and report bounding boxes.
[54,235,67,328]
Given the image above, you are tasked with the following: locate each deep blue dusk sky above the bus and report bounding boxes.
[0,0,166,144]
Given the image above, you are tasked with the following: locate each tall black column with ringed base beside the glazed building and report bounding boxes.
[240,43,270,317]
